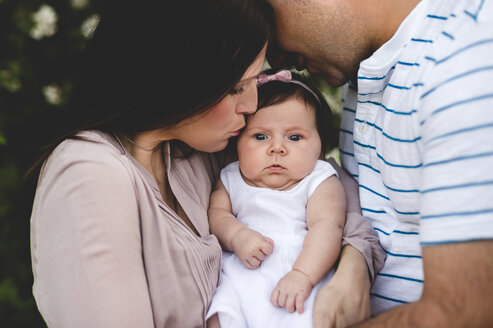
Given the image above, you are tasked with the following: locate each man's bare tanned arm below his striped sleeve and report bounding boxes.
[355,240,493,328]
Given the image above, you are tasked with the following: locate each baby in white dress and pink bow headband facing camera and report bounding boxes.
[207,70,346,328]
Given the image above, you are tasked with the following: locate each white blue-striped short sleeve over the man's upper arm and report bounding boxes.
[419,16,493,246]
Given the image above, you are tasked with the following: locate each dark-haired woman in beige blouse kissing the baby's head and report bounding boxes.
[31,0,380,327]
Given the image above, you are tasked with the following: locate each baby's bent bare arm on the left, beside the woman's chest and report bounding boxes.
[208,180,274,269]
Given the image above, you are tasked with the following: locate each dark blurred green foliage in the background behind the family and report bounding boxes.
[0,0,340,327]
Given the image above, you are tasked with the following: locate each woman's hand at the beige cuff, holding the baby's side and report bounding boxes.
[313,245,370,328]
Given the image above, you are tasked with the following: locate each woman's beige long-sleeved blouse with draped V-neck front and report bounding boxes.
[31,131,383,328]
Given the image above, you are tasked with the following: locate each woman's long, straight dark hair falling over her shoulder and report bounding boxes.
[29,0,274,177]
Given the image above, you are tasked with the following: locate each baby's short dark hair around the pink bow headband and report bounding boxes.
[253,69,337,156]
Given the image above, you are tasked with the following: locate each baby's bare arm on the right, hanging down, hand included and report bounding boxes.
[271,176,346,313]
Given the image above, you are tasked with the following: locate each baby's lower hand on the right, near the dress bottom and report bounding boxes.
[271,270,313,314]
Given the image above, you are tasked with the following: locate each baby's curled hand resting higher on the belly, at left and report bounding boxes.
[231,227,274,270]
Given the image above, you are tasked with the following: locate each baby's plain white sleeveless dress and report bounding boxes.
[207,160,336,328]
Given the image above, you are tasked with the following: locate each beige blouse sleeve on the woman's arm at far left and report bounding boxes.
[31,145,154,328]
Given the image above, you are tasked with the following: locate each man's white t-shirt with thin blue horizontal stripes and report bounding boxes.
[340,0,493,315]
